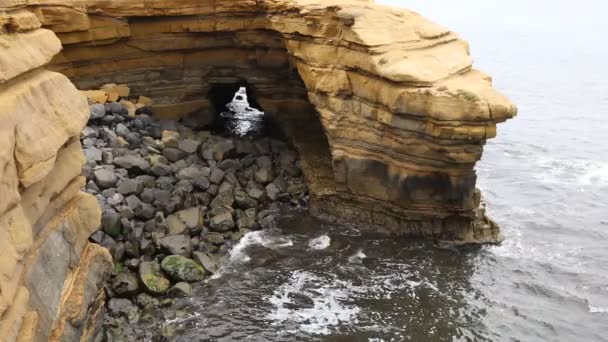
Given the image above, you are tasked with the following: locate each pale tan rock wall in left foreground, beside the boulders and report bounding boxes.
[0,8,111,341]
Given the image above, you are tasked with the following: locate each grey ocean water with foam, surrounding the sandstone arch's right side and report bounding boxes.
[145,0,608,342]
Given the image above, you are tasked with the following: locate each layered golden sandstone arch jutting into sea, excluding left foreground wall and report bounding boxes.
[17,0,516,241]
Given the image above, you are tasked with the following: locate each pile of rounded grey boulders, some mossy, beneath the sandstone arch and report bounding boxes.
[81,85,308,341]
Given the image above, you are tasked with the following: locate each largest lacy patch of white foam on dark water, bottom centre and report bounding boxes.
[266,271,360,335]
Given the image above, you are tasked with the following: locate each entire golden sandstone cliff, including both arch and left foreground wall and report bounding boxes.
[0,0,516,340]
